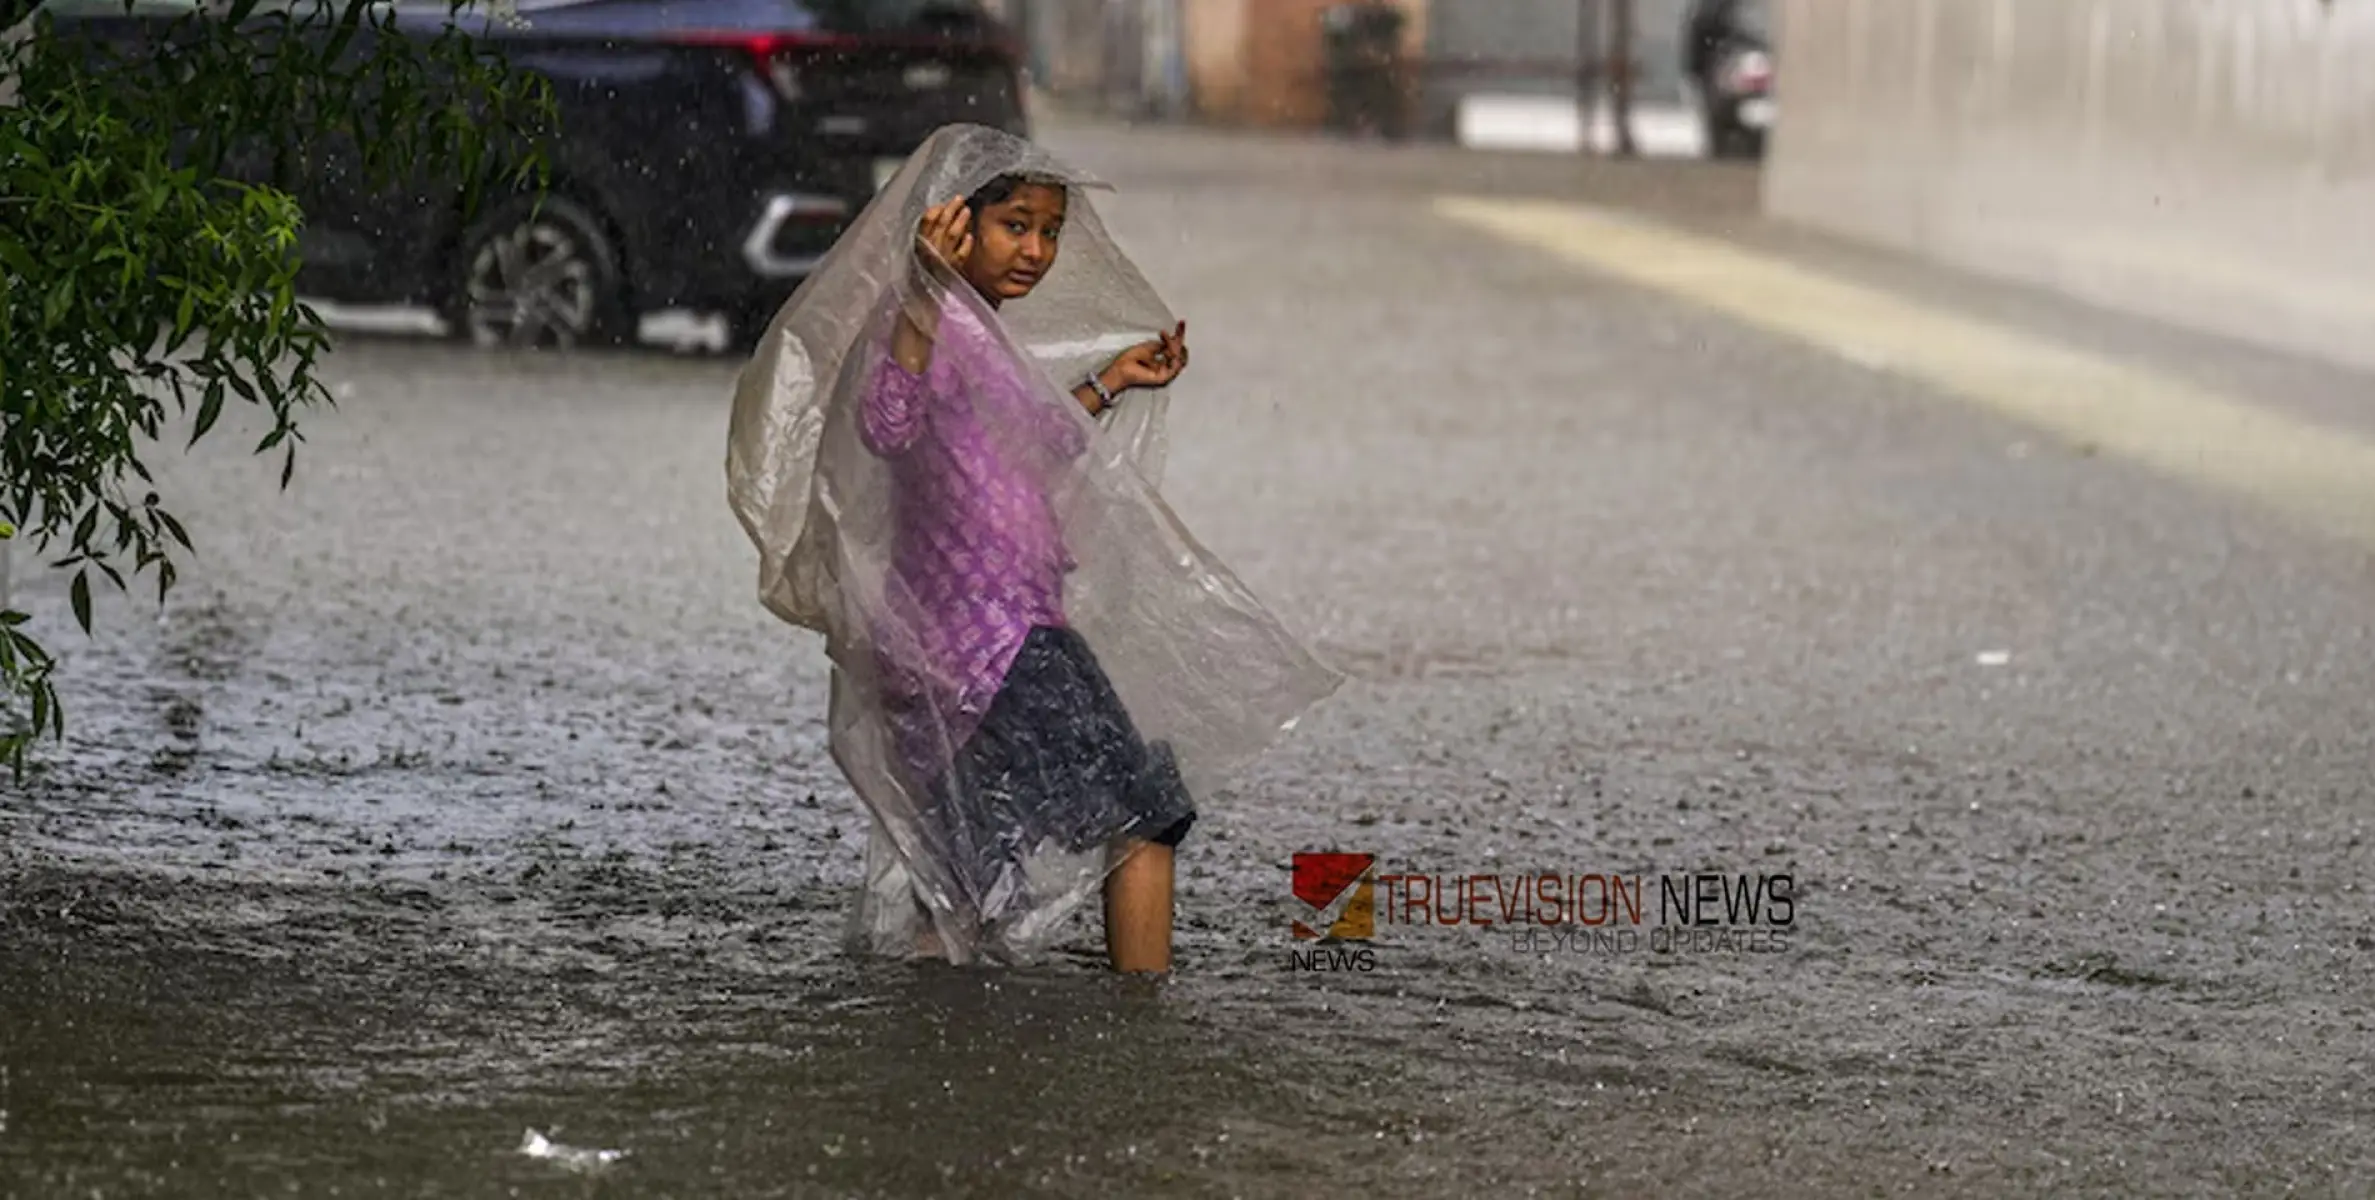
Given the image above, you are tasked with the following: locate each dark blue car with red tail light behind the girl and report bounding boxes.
[48,0,1028,345]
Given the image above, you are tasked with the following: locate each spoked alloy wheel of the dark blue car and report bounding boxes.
[447,195,634,349]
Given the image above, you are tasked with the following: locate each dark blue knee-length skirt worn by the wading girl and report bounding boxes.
[922,625,1195,922]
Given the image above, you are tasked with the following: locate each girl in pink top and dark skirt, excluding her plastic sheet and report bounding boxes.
[860,173,1195,972]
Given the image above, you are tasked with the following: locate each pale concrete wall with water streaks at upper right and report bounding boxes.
[1765,0,2375,368]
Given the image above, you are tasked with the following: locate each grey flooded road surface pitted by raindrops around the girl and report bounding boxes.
[0,119,2375,1198]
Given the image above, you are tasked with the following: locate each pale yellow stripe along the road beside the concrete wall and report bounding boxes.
[1435,197,2375,547]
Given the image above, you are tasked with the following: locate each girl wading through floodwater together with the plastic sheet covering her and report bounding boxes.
[727,126,1340,972]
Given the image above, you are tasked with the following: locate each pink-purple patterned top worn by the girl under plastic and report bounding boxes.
[860,304,1088,782]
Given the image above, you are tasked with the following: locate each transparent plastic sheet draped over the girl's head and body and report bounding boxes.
[727,126,1342,962]
